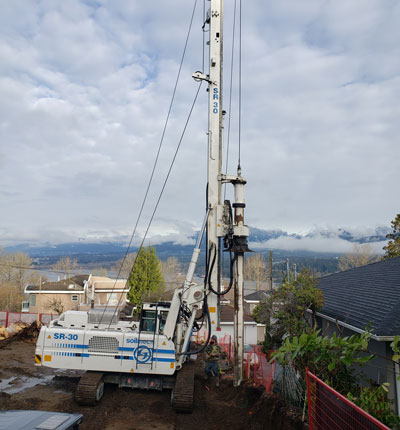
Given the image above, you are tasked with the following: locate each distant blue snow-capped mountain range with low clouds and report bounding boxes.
[4,227,390,258]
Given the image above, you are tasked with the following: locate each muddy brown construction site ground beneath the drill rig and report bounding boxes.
[0,339,303,430]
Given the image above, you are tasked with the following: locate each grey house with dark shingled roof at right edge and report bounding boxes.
[316,257,400,415]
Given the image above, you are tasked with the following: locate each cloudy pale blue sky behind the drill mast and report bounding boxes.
[0,0,400,249]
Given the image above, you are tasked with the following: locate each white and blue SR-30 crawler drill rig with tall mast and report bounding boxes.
[35,0,249,412]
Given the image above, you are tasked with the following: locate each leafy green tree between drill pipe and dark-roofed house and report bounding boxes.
[253,268,324,349]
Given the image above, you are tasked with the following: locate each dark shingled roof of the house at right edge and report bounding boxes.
[318,257,400,336]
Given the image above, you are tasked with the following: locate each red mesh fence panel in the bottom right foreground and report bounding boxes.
[306,369,390,430]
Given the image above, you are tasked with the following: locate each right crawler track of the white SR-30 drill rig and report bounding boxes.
[172,363,194,414]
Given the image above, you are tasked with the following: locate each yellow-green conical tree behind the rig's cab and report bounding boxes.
[128,247,165,308]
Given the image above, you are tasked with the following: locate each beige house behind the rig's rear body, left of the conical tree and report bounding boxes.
[22,275,129,313]
